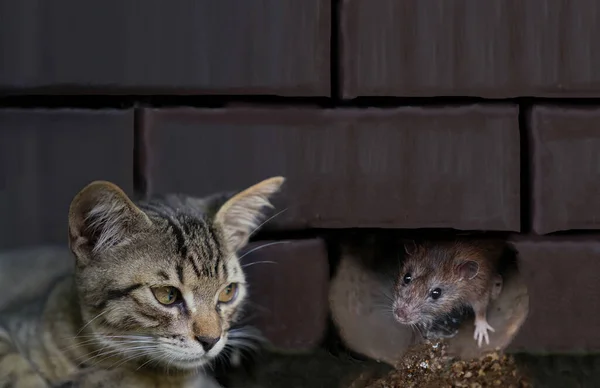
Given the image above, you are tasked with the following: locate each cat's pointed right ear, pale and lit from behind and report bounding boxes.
[215,177,285,251]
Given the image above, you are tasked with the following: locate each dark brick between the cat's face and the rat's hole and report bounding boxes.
[240,239,329,350]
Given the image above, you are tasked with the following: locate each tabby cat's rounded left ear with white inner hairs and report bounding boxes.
[69,181,152,262]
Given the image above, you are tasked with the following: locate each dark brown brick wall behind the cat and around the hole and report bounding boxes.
[0,0,600,352]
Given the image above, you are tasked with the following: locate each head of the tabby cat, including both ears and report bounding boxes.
[69,177,284,369]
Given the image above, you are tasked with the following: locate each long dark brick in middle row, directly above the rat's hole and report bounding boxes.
[145,105,520,231]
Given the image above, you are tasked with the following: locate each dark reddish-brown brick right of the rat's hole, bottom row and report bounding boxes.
[510,237,600,353]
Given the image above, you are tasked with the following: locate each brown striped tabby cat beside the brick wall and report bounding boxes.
[0,177,284,388]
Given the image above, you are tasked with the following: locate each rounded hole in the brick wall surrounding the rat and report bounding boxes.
[329,230,529,365]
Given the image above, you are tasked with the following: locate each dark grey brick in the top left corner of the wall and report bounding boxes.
[0,0,331,96]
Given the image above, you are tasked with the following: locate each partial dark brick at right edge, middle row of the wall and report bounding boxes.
[530,106,600,234]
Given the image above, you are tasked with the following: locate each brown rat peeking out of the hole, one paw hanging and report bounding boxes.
[393,240,504,347]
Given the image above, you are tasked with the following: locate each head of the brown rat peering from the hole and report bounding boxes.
[393,243,480,325]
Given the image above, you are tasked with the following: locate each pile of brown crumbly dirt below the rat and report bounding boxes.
[368,342,532,388]
